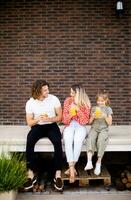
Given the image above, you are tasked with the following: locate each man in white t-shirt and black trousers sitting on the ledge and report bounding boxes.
[25,80,63,190]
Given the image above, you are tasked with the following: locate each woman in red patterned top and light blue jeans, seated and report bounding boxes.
[62,85,91,183]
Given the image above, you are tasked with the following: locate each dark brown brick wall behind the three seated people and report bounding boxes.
[0,0,131,124]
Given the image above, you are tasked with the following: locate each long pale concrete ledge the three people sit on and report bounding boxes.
[0,125,131,152]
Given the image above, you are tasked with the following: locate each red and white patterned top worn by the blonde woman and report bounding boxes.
[62,97,90,125]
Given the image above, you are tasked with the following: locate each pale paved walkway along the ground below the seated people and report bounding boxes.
[16,188,131,200]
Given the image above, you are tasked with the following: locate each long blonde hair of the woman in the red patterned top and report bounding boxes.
[71,84,91,108]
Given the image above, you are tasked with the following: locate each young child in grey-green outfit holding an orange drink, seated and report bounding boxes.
[84,93,113,175]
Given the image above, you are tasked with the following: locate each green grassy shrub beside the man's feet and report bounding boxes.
[0,154,27,192]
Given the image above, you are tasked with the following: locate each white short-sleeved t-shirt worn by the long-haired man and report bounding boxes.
[26,94,61,124]
